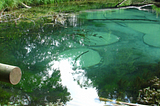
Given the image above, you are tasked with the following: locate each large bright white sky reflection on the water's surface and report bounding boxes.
[48,58,104,106]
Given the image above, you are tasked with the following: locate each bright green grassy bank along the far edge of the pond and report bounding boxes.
[0,0,155,10]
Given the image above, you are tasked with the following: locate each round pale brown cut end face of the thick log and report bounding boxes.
[9,67,22,85]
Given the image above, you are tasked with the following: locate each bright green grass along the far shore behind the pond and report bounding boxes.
[0,0,136,10]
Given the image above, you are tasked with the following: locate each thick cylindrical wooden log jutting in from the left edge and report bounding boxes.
[0,63,22,85]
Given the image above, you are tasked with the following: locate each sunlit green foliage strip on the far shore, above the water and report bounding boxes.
[0,0,154,10]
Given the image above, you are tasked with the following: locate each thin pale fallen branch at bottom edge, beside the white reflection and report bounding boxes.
[99,97,149,106]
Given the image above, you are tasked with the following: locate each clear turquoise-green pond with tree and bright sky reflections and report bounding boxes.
[0,8,160,106]
